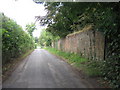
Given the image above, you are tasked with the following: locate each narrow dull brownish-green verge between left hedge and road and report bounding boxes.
[2,49,34,82]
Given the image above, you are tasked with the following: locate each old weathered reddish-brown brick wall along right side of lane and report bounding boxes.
[52,28,104,60]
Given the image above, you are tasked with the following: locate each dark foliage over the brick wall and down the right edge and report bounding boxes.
[34,2,120,88]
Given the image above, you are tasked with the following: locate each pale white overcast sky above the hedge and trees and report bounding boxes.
[0,0,46,37]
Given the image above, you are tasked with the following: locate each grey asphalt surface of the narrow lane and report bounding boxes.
[3,49,92,88]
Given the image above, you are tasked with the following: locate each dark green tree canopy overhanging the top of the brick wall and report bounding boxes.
[36,0,118,37]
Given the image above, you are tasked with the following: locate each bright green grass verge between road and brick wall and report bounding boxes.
[44,47,101,77]
